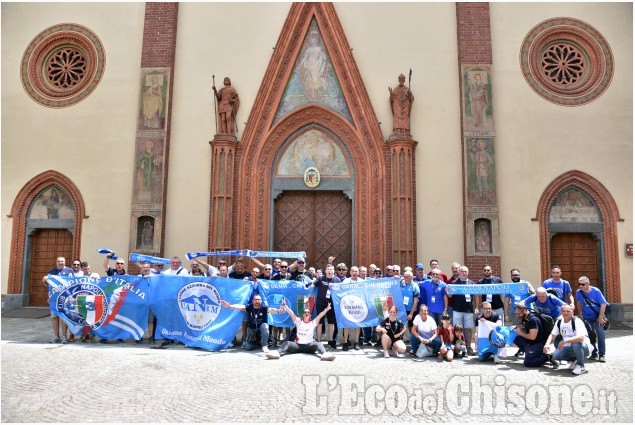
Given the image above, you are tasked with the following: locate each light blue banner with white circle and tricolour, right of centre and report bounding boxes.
[330,278,408,328]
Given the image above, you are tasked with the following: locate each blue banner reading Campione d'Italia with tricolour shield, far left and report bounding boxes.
[48,275,149,340]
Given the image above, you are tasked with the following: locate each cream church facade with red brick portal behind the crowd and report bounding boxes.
[2,3,633,310]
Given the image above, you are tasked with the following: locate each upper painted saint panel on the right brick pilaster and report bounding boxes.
[463,65,494,132]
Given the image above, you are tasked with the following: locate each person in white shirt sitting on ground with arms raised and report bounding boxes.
[278,302,335,360]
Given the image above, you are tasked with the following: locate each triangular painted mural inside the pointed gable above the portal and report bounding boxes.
[273,19,353,124]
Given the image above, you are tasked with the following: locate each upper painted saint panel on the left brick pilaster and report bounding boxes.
[138,68,170,130]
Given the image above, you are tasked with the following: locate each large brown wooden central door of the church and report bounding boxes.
[274,191,352,269]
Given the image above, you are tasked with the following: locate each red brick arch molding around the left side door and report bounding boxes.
[8,170,86,294]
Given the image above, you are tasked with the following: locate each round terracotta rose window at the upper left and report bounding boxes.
[20,24,106,108]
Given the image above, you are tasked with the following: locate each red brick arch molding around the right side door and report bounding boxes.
[536,170,621,302]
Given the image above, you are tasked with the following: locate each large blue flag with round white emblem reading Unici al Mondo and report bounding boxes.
[150,275,252,350]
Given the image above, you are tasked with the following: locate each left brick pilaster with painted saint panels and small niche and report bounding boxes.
[129,3,179,273]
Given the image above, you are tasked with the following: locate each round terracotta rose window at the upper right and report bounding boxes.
[520,18,614,106]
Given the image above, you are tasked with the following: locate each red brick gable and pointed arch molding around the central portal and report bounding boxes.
[230,3,392,264]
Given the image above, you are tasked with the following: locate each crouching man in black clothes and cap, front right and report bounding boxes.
[512,302,558,368]
